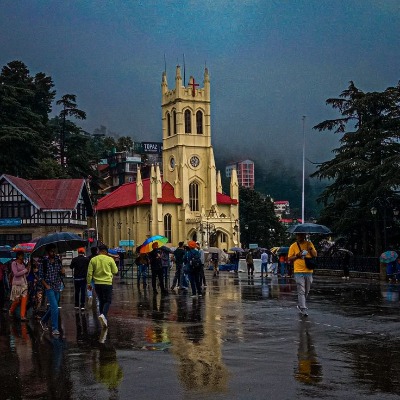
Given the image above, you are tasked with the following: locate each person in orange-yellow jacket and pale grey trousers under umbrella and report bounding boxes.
[288,233,317,316]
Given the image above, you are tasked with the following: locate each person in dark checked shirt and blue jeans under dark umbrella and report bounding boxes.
[39,244,65,336]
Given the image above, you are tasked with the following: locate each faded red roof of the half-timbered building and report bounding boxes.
[3,175,85,210]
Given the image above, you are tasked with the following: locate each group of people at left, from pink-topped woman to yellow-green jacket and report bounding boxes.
[0,244,118,337]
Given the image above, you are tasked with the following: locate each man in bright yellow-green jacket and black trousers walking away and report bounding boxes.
[86,244,118,328]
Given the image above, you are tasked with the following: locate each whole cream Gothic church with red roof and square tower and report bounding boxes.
[96,66,240,249]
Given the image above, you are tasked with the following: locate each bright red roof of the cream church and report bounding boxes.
[96,179,238,211]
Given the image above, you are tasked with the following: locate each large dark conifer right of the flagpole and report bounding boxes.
[312,82,400,254]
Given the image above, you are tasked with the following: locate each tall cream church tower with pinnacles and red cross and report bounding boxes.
[161,66,217,219]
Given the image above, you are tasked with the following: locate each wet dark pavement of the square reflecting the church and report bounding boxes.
[0,271,400,400]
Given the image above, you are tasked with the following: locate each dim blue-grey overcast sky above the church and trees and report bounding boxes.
[0,0,400,172]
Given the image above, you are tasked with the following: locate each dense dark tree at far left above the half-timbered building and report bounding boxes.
[0,61,55,178]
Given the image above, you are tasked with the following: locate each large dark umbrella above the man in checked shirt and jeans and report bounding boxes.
[32,232,87,257]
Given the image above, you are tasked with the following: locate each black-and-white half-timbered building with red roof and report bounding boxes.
[0,174,93,246]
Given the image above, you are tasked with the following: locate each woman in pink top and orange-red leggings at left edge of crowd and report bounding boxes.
[9,251,30,321]
